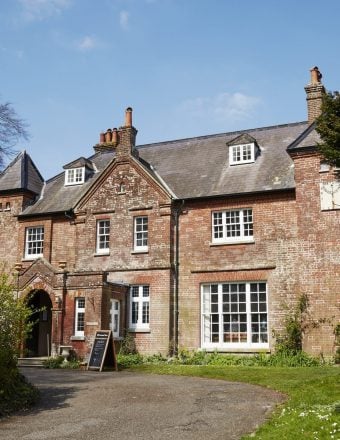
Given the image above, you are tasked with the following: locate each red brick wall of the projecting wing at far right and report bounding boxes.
[294,154,340,354]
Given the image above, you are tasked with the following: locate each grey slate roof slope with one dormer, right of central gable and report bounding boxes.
[139,122,308,199]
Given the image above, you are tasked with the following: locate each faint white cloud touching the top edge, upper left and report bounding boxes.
[19,0,71,21]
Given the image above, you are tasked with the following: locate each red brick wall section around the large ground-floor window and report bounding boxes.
[175,191,298,349]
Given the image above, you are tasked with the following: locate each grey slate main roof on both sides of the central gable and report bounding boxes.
[15,122,315,216]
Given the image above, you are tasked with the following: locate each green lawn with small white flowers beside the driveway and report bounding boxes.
[133,365,340,440]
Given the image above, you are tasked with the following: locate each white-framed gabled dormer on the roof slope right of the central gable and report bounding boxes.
[227,133,260,165]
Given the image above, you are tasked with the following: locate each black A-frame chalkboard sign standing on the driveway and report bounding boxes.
[87,330,118,371]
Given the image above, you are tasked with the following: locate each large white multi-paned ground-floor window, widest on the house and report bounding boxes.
[201,282,268,349]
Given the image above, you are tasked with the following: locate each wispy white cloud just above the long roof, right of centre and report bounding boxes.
[179,92,260,123]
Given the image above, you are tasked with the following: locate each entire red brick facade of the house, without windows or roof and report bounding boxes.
[4,149,340,356]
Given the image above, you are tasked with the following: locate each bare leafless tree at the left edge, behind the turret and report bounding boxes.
[0,102,29,169]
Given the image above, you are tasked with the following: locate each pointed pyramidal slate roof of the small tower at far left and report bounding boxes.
[0,151,44,194]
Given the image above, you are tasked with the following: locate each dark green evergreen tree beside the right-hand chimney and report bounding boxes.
[315,92,340,167]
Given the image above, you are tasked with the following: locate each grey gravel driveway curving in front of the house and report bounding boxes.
[0,368,283,440]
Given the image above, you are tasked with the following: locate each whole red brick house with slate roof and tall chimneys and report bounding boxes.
[0,68,340,357]
